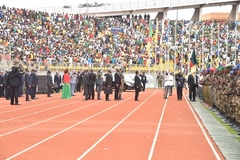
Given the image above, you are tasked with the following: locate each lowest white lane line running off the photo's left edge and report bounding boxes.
[0,101,100,138]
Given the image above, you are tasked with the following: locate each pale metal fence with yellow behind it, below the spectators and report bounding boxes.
[0,60,181,73]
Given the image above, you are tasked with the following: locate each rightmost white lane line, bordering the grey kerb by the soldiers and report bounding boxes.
[183,95,221,160]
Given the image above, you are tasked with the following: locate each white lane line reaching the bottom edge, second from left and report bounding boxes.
[77,90,158,160]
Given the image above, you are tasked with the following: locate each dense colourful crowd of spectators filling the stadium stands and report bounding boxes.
[0,6,240,74]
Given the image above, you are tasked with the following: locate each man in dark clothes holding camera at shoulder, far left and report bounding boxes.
[6,66,22,105]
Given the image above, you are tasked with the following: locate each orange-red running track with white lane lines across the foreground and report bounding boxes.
[0,89,224,160]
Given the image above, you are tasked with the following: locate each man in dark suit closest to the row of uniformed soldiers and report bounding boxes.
[188,74,198,101]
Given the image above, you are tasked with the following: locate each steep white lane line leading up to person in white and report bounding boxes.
[148,96,168,160]
